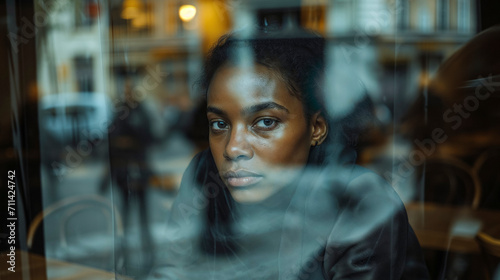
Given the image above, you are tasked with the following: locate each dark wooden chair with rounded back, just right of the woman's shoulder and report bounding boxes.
[417,154,481,279]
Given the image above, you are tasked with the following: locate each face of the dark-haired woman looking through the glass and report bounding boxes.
[207,65,324,203]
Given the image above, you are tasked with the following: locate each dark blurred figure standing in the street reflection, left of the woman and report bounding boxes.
[107,80,155,273]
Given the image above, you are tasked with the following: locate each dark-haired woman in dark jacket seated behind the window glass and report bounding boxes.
[151,27,428,279]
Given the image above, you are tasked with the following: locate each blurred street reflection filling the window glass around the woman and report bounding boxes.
[0,0,500,279]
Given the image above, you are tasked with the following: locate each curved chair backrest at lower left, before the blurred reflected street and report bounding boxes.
[27,195,123,269]
